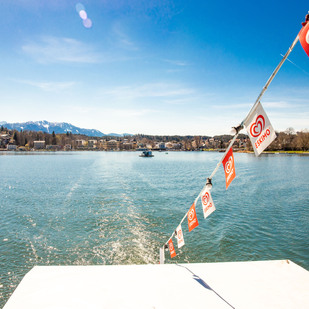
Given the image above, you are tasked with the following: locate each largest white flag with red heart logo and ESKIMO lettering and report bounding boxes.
[244,102,276,156]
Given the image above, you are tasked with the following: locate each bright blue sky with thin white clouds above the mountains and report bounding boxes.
[0,0,309,135]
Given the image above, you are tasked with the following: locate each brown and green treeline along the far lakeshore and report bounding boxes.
[0,126,309,151]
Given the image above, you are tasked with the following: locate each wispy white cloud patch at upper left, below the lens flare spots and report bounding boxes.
[22,36,100,63]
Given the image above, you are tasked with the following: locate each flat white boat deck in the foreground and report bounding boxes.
[4,260,309,309]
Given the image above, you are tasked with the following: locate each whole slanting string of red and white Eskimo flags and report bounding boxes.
[160,12,309,264]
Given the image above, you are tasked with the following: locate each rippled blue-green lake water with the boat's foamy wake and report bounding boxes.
[0,152,309,307]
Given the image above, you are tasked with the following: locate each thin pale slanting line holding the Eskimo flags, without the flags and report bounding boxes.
[163,26,299,258]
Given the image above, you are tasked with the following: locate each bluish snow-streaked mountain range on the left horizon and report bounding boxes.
[0,120,131,137]
